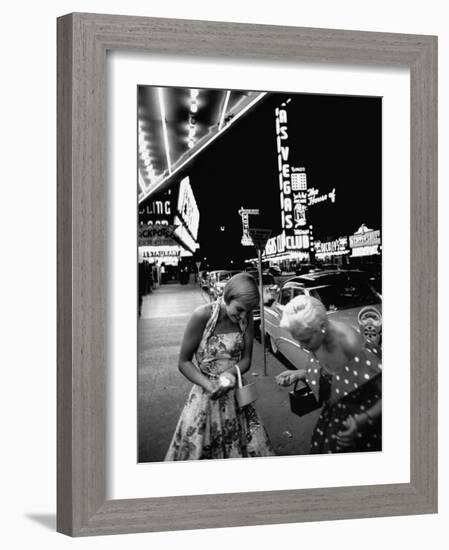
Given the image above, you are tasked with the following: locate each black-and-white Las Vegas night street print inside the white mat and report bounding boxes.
[136,86,382,462]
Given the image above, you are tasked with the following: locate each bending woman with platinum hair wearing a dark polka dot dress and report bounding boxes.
[276,296,382,453]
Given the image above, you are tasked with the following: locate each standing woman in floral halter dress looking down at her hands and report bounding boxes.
[165,273,273,460]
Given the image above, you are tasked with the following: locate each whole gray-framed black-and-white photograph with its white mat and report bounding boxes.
[58,14,437,536]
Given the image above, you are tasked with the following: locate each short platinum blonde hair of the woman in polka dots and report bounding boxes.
[279,296,327,333]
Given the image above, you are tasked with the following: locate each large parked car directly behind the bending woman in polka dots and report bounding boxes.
[264,270,382,368]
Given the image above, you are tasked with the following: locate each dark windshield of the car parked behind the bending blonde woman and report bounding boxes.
[310,283,379,311]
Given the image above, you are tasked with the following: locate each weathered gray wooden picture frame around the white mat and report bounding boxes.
[57,13,437,536]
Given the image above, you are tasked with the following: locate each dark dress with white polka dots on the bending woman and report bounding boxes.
[306,346,382,454]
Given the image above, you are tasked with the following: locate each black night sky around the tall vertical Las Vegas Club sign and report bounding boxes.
[142,93,382,268]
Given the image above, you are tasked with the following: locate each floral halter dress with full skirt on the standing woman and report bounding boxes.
[165,302,274,460]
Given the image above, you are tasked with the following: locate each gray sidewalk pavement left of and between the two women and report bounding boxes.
[138,283,319,462]
